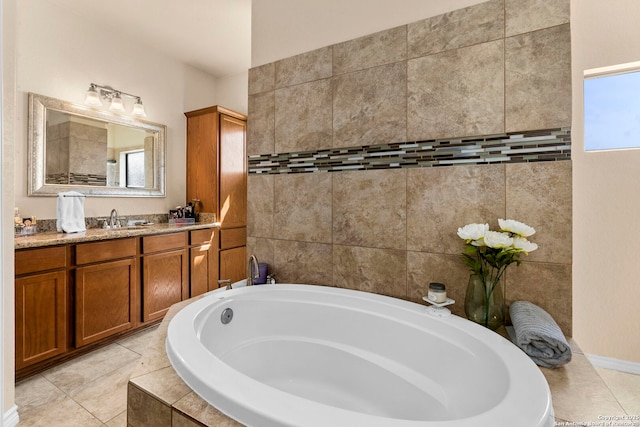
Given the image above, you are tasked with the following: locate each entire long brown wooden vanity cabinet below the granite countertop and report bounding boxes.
[15,226,220,379]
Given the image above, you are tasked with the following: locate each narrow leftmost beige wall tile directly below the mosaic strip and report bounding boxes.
[247,175,275,237]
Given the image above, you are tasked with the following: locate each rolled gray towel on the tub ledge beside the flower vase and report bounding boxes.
[509,301,571,368]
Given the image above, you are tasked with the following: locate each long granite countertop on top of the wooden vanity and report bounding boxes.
[14,222,220,249]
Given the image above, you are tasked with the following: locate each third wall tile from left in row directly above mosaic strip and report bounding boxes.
[332,62,407,147]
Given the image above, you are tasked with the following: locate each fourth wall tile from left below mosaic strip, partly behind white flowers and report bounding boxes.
[407,165,505,254]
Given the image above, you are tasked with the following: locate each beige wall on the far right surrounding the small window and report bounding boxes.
[571,0,640,363]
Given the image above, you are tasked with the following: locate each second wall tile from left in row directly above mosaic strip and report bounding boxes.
[275,79,333,153]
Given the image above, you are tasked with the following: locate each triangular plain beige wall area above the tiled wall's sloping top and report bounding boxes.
[251,0,486,67]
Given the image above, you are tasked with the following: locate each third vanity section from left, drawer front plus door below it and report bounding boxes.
[142,232,189,322]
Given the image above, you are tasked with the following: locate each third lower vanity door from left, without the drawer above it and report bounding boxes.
[142,249,189,322]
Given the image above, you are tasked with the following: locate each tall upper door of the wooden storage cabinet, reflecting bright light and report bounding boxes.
[219,114,247,228]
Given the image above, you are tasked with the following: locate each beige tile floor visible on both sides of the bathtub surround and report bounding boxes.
[16,327,640,427]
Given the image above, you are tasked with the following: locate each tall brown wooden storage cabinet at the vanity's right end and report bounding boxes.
[185,106,247,289]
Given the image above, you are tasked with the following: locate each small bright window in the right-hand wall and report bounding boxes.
[584,62,640,151]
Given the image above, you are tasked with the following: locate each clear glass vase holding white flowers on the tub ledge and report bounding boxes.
[458,219,538,330]
